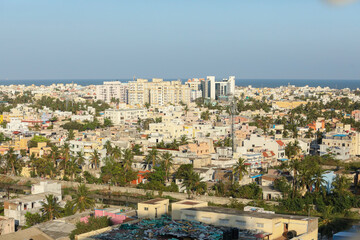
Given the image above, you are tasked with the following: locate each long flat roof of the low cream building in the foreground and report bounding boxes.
[183,206,316,221]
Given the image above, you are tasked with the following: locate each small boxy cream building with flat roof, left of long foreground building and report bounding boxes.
[138,198,169,219]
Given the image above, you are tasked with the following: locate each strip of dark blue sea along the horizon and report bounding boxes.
[0,79,360,90]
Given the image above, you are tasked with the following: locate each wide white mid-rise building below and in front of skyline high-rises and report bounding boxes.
[105,108,147,125]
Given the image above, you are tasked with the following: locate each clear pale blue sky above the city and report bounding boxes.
[0,0,360,80]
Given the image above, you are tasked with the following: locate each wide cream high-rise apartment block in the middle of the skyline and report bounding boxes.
[129,78,190,106]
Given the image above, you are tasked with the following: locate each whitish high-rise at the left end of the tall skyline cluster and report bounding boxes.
[96,81,128,103]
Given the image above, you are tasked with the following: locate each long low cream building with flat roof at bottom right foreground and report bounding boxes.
[180,207,318,240]
